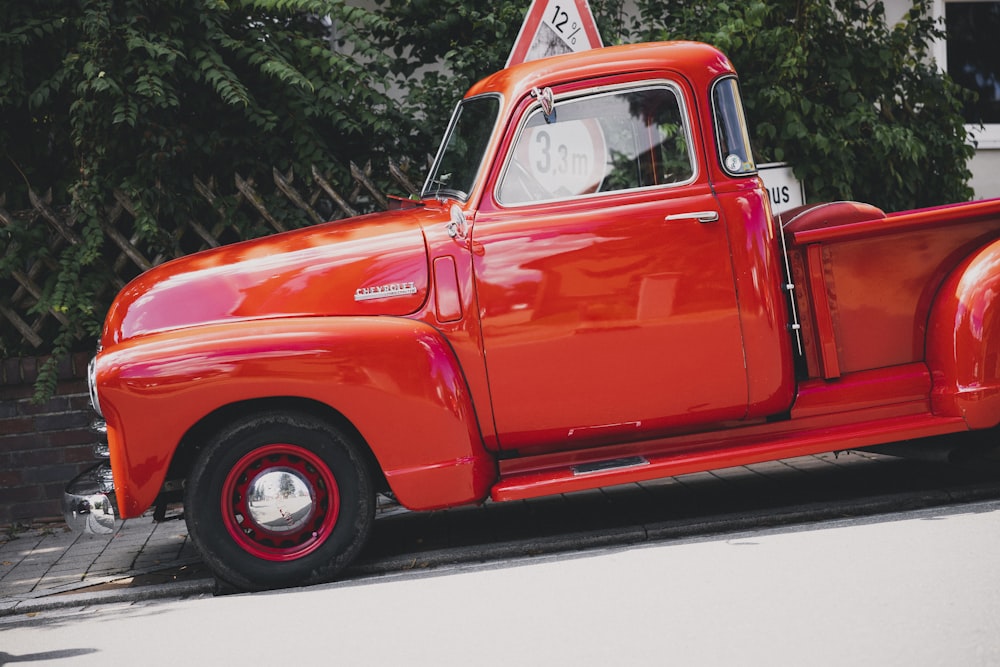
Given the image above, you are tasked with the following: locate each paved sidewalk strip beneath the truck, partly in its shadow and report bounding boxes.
[0,452,1000,616]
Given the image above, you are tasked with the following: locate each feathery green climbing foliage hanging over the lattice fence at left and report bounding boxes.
[0,0,400,396]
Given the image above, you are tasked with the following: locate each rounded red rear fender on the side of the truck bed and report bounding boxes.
[926,240,1000,429]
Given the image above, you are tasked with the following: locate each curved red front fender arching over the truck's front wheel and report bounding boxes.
[97,317,496,518]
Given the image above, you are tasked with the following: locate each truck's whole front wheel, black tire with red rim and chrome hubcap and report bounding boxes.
[184,412,375,590]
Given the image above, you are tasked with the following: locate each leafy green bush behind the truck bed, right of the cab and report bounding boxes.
[634,0,974,211]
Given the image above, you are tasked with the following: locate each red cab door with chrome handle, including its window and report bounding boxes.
[472,80,747,451]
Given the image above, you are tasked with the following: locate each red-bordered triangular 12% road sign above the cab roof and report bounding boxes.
[506,0,604,67]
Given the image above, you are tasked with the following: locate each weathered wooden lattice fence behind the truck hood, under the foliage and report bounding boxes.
[0,160,418,357]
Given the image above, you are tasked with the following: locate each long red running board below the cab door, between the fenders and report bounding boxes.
[490,414,968,501]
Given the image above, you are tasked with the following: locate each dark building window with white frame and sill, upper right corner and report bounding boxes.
[936,0,1000,148]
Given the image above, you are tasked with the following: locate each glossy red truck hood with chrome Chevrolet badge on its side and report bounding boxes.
[101,207,447,347]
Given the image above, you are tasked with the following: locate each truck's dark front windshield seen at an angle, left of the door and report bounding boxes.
[421,95,500,201]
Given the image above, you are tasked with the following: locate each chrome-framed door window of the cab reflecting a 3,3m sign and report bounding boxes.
[497,84,695,206]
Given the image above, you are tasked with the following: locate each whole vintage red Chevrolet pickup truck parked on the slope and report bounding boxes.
[65,43,1000,589]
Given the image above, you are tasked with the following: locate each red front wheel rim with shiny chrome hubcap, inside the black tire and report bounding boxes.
[221,444,340,562]
